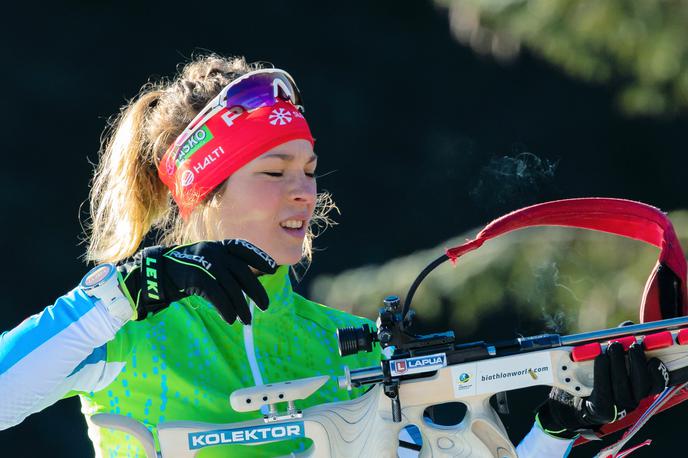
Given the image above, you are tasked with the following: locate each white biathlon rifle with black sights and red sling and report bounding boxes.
[91,199,688,458]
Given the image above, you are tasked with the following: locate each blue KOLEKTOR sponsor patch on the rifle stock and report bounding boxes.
[188,421,304,450]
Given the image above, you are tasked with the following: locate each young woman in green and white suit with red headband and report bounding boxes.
[0,55,668,457]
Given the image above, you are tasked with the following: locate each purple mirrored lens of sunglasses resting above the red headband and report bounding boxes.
[223,73,301,110]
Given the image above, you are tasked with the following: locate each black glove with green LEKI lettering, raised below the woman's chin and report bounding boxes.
[117,239,277,324]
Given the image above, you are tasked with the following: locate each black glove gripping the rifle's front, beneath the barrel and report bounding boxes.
[537,342,669,439]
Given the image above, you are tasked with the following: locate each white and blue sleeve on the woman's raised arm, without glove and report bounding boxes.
[0,288,125,430]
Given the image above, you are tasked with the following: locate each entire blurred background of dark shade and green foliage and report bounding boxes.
[0,0,688,457]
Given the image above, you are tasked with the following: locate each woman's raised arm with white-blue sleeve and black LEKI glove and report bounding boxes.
[0,240,277,430]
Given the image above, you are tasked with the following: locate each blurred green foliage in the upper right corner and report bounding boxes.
[435,0,688,115]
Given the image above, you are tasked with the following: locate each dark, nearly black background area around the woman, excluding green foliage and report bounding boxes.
[0,0,688,457]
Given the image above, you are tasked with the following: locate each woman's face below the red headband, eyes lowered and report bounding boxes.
[215,140,317,265]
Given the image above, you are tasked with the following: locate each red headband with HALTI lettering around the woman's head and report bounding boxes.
[158,100,315,218]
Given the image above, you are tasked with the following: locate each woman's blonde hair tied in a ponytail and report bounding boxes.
[85,54,336,263]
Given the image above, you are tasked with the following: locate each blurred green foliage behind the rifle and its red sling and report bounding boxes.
[311,211,688,334]
